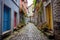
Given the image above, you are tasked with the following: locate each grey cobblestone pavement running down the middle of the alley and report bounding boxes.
[4,23,48,40]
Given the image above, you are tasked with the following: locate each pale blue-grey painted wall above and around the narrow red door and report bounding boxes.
[2,0,20,31]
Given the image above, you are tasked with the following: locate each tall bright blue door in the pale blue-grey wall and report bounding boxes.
[2,5,11,32]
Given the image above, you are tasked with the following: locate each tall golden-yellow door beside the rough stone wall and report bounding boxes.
[46,4,53,29]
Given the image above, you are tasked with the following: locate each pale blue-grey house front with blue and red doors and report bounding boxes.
[0,0,20,35]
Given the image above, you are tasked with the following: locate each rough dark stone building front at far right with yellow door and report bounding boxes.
[44,0,60,40]
